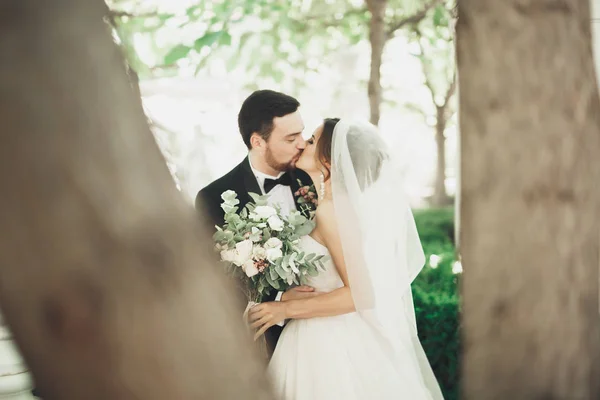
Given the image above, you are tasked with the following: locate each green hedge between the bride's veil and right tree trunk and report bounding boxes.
[412,208,460,400]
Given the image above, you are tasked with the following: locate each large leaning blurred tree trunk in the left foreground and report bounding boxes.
[0,0,270,400]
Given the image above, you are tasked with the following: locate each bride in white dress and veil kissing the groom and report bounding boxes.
[249,119,443,400]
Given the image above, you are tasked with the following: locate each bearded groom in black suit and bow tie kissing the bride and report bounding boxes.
[196,90,313,356]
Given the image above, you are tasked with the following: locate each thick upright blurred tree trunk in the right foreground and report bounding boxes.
[457,0,600,400]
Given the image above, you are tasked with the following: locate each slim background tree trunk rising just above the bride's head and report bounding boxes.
[367,0,387,125]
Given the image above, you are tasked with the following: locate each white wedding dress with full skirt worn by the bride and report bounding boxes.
[269,236,439,400]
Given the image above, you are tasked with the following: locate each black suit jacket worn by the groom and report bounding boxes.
[196,157,313,357]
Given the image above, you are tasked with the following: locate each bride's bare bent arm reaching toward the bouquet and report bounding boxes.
[284,202,356,319]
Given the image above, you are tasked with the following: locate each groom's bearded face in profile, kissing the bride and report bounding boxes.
[264,111,306,171]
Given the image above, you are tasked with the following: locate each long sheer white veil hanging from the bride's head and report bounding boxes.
[331,120,443,400]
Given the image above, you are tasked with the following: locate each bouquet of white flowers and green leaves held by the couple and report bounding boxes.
[213,190,324,303]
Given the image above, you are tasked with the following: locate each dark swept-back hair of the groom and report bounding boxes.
[238,90,300,149]
